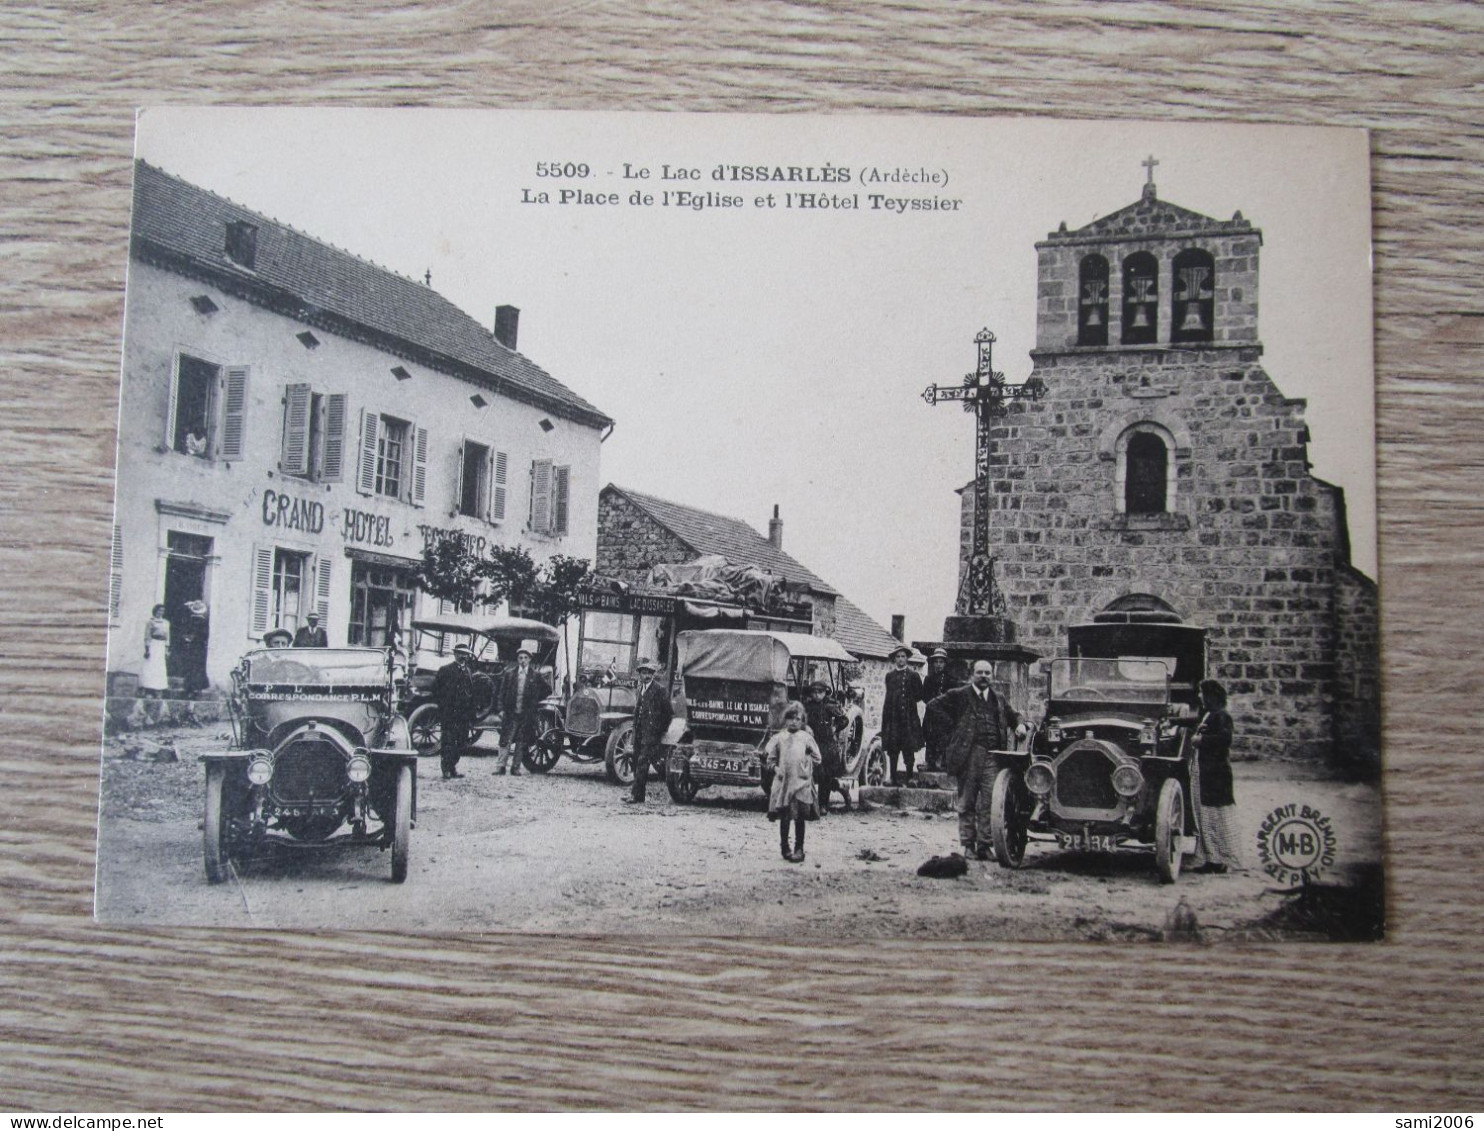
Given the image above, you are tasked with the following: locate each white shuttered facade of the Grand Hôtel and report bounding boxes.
[108,258,603,684]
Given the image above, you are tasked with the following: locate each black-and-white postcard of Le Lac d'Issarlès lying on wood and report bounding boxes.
[96,108,1385,943]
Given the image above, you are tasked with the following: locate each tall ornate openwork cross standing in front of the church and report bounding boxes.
[923,330,1046,616]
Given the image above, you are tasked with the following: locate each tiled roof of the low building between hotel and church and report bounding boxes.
[604,484,899,658]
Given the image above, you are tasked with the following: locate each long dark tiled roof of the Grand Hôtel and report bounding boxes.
[132,160,611,427]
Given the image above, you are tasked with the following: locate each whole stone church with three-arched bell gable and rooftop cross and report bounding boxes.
[962,165,1380,767]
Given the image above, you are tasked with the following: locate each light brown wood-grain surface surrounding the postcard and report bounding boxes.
[0,0,1484,1112]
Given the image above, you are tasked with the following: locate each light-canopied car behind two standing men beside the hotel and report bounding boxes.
[398,616,561,756]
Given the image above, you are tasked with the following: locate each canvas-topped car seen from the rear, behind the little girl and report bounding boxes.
[665,629,880,803]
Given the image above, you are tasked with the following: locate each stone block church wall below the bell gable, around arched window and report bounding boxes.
[965,347,1361,758]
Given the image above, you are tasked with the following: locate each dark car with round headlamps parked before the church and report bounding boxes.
[990,612,1205,883]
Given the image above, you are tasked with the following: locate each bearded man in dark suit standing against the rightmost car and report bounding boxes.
[928,660,1018,859]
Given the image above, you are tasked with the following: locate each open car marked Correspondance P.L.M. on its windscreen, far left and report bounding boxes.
[202,649,417,883]
